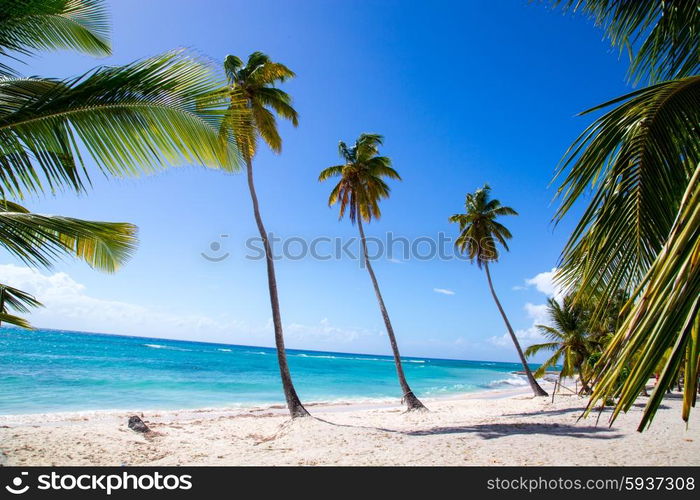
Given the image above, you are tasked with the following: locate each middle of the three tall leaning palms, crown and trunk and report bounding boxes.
[318,134,426,411]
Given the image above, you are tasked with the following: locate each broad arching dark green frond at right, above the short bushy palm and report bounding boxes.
[556,76,700,314]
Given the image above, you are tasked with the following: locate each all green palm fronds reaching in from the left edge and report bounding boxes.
[0,0,236,326]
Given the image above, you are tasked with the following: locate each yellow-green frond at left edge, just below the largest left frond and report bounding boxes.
[0,201,137,272]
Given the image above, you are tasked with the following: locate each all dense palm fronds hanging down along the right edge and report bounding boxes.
[555,0,700,431]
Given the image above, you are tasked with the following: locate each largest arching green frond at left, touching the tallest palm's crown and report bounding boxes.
[0,52,237,198]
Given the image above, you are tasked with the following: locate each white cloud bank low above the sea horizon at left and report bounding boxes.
[0,264,377,349]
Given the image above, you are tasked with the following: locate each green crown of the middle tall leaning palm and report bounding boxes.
[318,134,401,224]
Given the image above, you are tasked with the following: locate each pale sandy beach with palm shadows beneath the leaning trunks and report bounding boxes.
[0,389,700,465]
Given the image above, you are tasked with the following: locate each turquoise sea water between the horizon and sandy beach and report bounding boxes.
[0,328,526,414]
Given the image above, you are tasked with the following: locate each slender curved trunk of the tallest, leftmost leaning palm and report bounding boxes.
[246,158,309,418]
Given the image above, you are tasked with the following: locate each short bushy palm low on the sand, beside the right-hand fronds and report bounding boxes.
[525,296,594,394]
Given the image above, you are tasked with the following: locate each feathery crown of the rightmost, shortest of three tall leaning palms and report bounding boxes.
[449,184,518,267]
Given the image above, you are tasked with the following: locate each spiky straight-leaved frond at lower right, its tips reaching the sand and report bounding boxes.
[587,167,700,431]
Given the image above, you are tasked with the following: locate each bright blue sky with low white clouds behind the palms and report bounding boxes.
[0,0,628,361]
